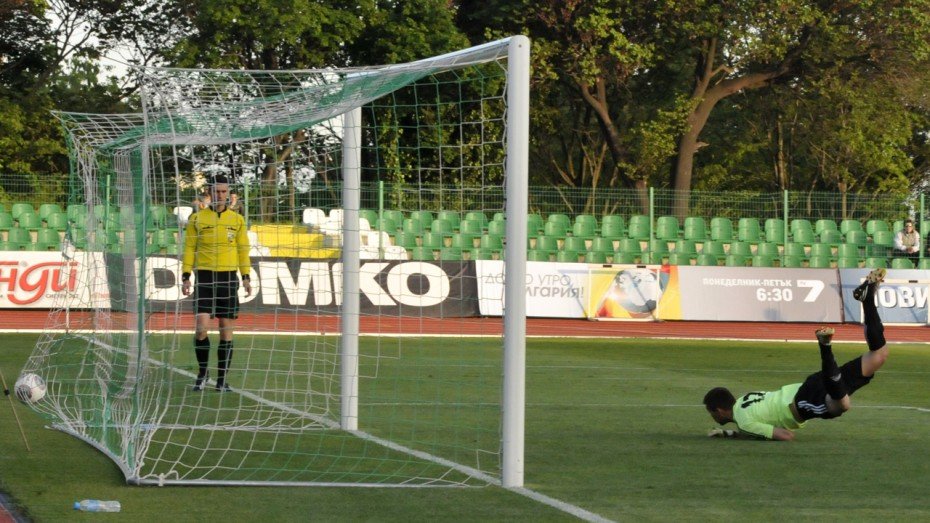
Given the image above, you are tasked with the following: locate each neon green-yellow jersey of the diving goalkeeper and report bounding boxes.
[733,383,804,439]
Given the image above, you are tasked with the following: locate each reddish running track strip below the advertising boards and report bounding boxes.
[0,310,930,343]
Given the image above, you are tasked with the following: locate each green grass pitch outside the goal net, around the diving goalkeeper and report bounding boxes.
[0,334,930,522]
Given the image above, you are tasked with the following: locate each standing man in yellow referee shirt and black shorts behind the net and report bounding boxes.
[181,175,252,392]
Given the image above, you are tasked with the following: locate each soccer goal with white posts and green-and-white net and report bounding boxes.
[24,36,529,487]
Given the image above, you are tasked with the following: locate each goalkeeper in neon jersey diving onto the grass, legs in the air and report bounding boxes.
[704,269,888,441]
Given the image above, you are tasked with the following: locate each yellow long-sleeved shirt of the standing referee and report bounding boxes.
[181,209,252,276]
